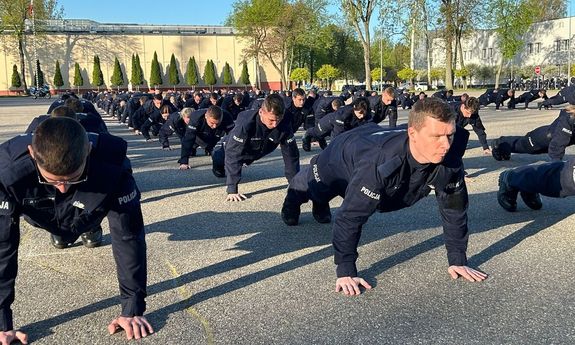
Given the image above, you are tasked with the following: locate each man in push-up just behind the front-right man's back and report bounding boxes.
[302,97,368,151]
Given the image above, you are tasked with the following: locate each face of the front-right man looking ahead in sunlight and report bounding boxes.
[407,116,455,164]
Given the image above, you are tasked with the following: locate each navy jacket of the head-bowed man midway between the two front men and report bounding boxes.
[224,109,299,194]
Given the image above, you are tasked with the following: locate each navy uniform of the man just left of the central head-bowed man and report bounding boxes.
[178,109,234,164]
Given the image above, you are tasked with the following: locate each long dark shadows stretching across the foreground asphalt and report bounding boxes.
[23,192,575,340]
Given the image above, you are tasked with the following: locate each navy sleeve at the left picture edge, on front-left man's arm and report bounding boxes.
[0,186,20,331]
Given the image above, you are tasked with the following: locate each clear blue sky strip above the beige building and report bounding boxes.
[58,0,238,25]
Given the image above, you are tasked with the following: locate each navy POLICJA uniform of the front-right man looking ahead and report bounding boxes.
[284,123,469,277]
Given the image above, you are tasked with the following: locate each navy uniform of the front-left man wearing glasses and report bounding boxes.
[0,134,147,331]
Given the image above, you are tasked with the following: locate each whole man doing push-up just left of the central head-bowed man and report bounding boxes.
[178,105,234,170]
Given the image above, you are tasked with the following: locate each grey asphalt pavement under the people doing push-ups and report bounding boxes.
[0,92,575,345]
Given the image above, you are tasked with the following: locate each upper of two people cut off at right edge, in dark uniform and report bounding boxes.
[491,106,575,161]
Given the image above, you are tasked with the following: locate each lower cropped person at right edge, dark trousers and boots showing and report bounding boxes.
[497,158,575,212]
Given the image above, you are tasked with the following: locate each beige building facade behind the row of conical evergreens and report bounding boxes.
[0,20,281,95]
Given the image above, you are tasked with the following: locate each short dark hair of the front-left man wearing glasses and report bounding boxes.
[32,117,90,176]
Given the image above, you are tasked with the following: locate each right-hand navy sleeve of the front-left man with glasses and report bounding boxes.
[108,170,147,317]
